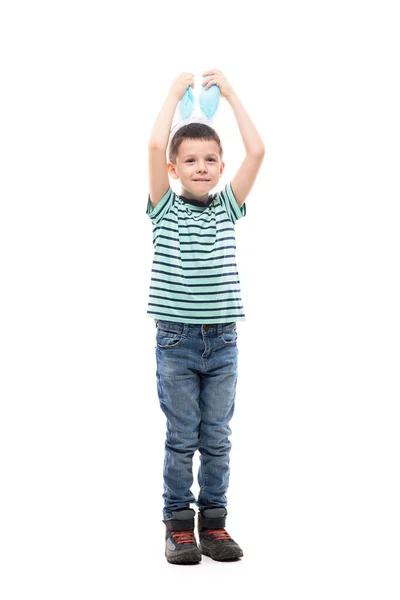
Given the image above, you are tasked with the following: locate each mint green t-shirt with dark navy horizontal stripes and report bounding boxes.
[146,184,246,324]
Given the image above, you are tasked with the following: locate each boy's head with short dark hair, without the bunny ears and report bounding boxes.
[168,123,225,201]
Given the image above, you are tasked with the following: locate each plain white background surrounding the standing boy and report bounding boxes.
[0,0,400,600]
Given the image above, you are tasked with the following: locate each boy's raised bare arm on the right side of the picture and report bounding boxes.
[203,69,265,206]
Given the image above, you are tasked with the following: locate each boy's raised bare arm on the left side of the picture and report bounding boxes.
[149,73,194,207]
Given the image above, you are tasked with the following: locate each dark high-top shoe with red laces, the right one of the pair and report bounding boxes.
[198,508,243,561]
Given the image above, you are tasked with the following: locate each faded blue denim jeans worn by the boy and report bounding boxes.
[156,320,238,520]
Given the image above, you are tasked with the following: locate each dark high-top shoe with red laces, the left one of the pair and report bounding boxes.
[164,508,201,565]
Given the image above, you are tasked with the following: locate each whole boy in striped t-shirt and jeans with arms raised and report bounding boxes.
[147,69,264,564]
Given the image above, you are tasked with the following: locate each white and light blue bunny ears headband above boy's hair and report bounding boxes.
[168,74,221,156]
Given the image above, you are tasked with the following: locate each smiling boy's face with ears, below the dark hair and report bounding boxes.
[168,139,225,202]
